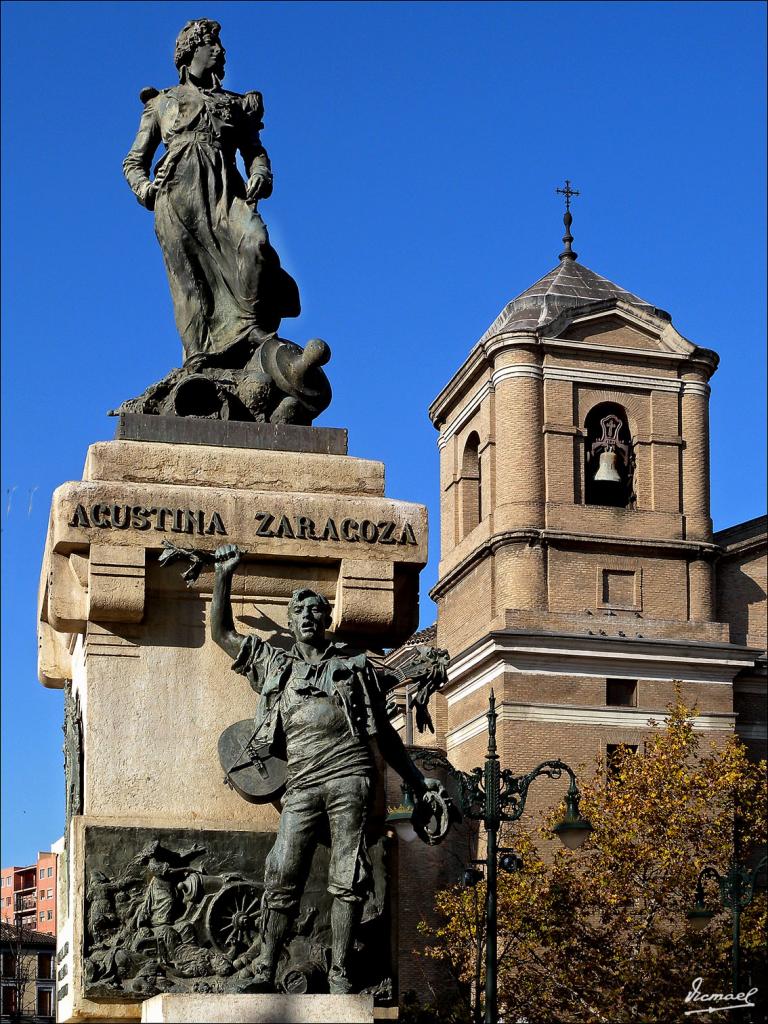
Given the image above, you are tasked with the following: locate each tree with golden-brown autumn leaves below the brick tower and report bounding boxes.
[423,692,766,1024]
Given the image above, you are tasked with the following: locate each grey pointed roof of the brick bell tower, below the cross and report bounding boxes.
[480,253,672,341]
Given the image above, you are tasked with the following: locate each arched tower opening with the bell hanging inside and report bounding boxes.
[585,401,635,508]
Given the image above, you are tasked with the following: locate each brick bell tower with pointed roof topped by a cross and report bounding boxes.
[429,190,758,782]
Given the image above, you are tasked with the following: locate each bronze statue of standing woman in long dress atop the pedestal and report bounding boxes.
[123,18,300,369]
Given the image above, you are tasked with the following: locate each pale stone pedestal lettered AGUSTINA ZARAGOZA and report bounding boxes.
[38,428,427,1021]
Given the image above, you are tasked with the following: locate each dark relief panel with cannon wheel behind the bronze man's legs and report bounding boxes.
[83,826,392,1001]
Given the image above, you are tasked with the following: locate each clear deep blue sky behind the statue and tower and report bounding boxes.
[1,0,766,864]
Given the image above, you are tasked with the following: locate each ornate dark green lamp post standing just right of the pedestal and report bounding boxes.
[414,690,592,1024]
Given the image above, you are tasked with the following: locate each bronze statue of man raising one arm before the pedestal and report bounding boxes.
[211,545,447,994]
